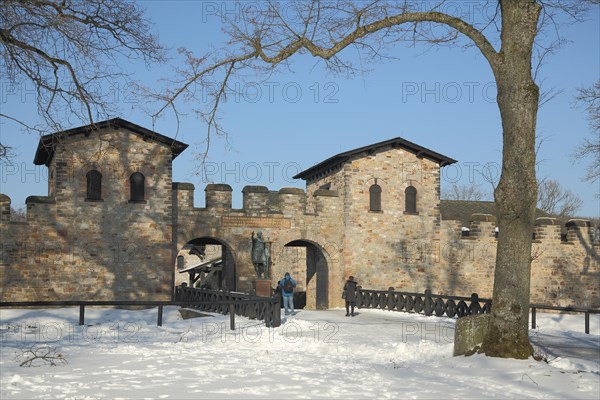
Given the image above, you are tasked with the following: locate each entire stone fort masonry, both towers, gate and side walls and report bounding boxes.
[0,129,600,308]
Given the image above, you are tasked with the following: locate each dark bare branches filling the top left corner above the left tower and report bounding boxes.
[0,0,164,159]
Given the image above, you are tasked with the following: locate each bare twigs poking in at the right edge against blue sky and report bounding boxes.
[573,80,600,182]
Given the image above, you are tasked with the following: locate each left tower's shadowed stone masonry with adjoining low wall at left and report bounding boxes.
[0,128,174,301]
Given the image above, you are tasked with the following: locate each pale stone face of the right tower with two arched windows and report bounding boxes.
[308,147,440,290]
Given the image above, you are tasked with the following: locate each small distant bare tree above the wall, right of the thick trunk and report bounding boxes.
[538,179,583,219]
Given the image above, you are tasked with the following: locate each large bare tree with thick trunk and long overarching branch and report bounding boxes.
[154,0,597,358]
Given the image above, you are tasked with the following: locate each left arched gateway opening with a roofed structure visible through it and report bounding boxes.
[175,237,237,291]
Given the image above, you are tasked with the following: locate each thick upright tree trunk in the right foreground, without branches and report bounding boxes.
[483,0,540,359]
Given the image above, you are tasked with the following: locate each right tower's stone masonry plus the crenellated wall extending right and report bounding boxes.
[307,148,600,307]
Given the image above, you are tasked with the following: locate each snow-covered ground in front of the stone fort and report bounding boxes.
[0,307,600,400]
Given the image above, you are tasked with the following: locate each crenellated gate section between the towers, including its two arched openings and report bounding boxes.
[173,183,342,309]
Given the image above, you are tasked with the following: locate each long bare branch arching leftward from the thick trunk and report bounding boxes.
[149,0,500,141]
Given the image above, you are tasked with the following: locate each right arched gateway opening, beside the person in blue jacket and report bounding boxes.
[284,240,329,310]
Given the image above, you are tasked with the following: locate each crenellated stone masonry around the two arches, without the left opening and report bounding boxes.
[174,183,343,306]
